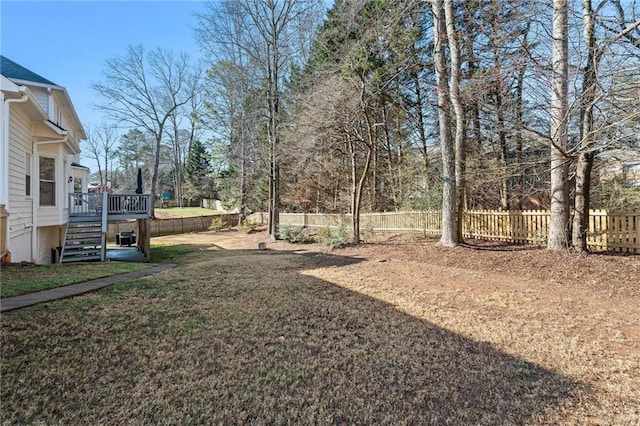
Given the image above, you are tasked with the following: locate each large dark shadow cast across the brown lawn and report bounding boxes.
[2,246,579,424]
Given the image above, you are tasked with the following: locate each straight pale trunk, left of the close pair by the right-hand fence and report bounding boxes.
[547,0,569,250]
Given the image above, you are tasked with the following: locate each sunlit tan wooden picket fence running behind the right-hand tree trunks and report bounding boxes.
[247,210,640,254]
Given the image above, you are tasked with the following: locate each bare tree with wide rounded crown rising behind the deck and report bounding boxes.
[92,45,193,214]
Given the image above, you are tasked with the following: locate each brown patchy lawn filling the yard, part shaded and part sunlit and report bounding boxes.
[0,231,640,425]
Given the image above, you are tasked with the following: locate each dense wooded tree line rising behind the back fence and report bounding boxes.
[91,0,640,249]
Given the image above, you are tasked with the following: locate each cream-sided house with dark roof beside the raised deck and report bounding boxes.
[0,56,89,264]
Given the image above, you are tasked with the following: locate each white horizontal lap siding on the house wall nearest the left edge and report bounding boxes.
[7,104,37,262]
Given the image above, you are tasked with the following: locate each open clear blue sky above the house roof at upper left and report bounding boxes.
[0,0,204,168]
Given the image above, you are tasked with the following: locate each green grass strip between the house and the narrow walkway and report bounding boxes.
[0,262,152,298]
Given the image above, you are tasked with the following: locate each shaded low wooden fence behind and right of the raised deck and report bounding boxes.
[107,213,238,241]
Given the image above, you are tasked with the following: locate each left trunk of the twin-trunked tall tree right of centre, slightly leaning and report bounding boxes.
[431,0,457,247]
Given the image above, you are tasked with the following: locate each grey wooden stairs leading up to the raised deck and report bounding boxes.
[60,215,106,263]
